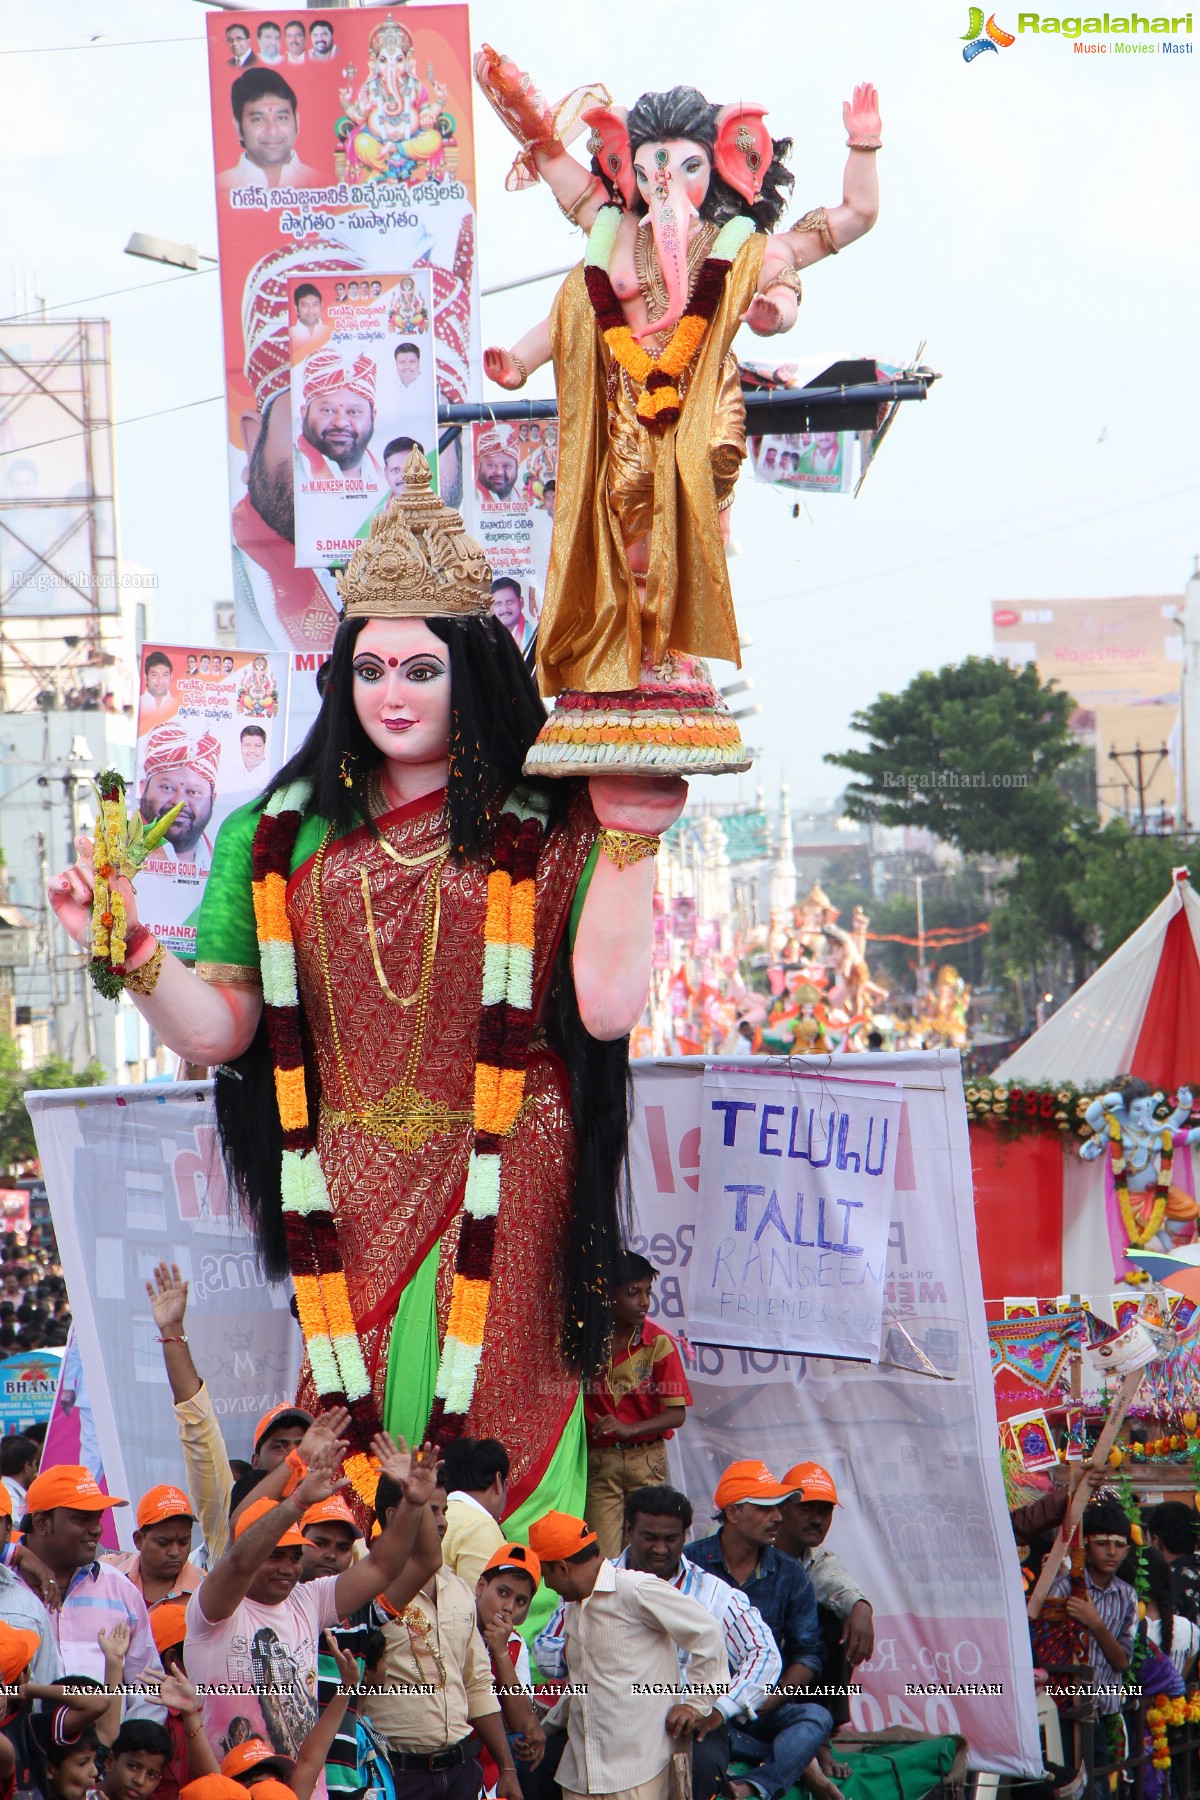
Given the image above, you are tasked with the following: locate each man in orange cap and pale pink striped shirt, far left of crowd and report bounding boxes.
[25,1463,166,1724]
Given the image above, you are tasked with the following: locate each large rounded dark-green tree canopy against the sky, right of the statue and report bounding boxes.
[826,657,1079,857]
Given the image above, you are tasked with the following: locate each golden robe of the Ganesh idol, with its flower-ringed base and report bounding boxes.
[527,232,766,774]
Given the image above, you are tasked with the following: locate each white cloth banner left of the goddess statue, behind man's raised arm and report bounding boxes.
[29,1082,300,1550]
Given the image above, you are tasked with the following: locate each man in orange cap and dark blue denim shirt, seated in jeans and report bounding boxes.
[685,1460,833,1800]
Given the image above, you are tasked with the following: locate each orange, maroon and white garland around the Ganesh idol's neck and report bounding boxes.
[583,207,756,432]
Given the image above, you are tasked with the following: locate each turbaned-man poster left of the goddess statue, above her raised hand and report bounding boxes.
[133,644,288,956]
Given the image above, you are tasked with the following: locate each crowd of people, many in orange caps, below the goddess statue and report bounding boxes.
[0,1256,873,1800]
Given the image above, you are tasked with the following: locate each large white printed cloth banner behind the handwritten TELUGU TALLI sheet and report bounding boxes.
[630,1051,1042,1775]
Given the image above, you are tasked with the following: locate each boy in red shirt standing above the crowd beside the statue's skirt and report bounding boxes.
[583,1251,691,1557]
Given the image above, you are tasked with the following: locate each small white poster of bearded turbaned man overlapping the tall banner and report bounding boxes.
[290,268,437,569]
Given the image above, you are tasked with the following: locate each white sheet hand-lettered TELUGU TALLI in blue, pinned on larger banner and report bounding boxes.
[693,1064,901,1363]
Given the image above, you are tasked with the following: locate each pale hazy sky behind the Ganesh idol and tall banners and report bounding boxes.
[0,0,1200,806]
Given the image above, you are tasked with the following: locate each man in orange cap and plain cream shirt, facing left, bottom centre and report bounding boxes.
[529,1512,729,1800]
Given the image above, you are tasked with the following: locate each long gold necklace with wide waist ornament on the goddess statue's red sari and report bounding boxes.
[313,824,475,1154]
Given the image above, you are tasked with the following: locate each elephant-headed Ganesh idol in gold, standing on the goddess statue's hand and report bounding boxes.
[475,45,880,776]
